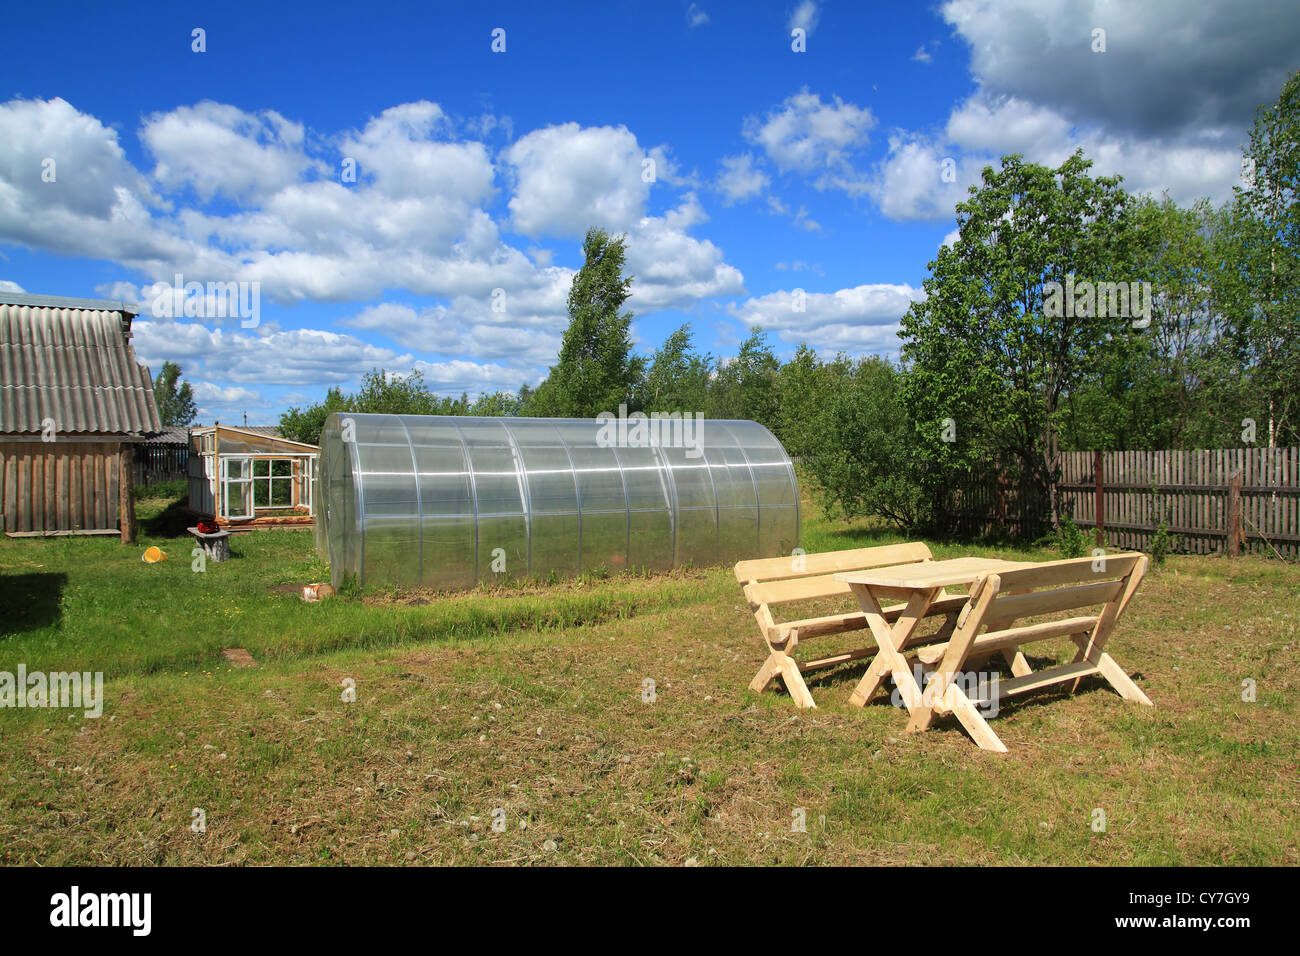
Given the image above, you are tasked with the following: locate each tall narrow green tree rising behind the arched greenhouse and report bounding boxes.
[529,228,644,419]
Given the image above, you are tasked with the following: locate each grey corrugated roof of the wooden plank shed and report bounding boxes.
[0,300,163,434]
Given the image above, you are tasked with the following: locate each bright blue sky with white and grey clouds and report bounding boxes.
[0,0,1300,423]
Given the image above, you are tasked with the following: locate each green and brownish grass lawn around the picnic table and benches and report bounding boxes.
[0,489,1300,865]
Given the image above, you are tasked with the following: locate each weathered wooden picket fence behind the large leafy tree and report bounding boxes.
[953,447,1300,558]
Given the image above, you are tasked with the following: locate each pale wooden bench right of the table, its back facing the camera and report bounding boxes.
[907,553,1152,753]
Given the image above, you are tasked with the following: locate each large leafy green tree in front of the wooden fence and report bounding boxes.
[900,152,1132,527]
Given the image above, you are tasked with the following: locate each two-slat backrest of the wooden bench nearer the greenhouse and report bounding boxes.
[736,541,932,610]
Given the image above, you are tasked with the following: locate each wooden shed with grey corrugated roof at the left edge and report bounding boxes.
[0,293,163,541]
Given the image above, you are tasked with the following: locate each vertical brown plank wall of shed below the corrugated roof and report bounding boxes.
[0,441,121,531]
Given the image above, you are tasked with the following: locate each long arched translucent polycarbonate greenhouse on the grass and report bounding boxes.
[315,412,800,588]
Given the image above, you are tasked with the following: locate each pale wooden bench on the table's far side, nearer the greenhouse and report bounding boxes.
[736,542,966,709]
